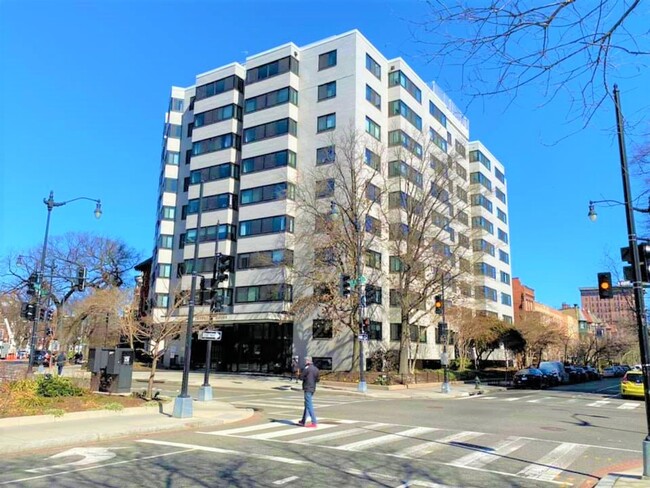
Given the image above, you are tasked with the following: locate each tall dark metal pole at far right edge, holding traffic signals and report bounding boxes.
[614,85,650,478]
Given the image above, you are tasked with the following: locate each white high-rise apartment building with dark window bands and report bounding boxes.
[150,30,513,372]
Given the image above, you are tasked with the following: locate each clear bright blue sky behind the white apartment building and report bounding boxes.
[0,0,650,307]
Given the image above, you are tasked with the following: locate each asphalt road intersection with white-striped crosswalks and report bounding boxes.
[0,380,645,488]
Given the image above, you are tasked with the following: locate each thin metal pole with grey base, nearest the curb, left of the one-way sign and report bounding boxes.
[172,179,203,418]
